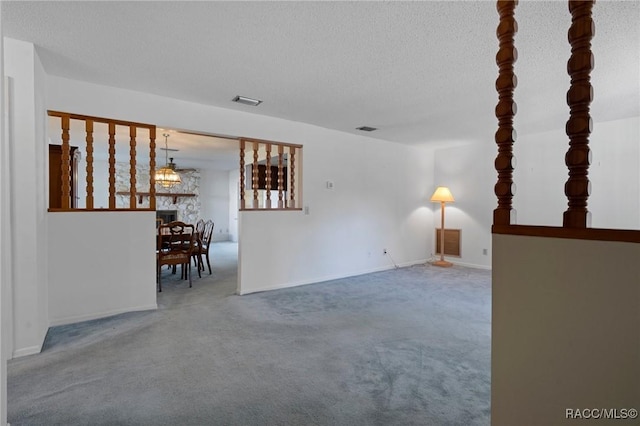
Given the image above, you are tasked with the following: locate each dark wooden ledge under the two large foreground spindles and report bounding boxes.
[491,225,640,243]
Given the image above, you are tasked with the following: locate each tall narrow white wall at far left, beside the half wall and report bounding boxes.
[4,39,48,356]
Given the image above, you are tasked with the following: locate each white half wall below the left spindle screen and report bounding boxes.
[47,212,157,326]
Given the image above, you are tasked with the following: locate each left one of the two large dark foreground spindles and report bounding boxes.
[493,0,518,225]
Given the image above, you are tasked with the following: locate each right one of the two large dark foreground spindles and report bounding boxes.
[563,0,595,228]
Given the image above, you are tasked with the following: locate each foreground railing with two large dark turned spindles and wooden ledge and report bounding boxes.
[492,0,640,243]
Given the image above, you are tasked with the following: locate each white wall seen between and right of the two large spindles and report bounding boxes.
[513,117,640,229]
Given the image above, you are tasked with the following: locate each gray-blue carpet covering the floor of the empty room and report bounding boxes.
[8,243,491,426]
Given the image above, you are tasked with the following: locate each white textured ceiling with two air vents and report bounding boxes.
[1,1,640,150]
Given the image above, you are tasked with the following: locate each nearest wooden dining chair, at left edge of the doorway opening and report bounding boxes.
[156,221,199,292]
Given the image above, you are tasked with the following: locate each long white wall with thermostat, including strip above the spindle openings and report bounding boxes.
[48,76,434,293]
